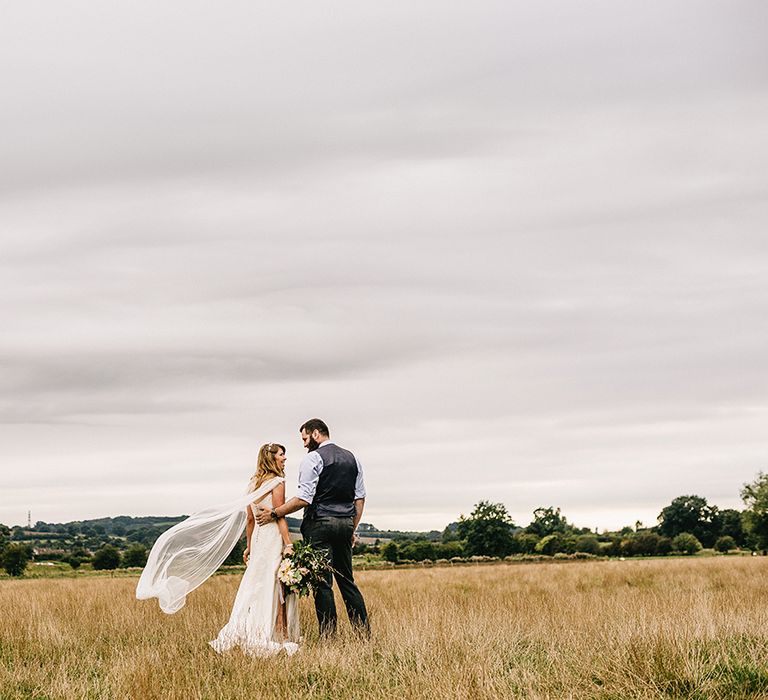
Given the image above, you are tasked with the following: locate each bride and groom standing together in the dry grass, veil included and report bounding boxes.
[136,418,370,656]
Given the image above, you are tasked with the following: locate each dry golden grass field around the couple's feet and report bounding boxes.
[0,557,768,700]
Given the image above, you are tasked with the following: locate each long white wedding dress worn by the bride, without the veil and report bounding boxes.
[210,492,300,656]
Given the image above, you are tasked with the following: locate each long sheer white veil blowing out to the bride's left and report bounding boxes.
[136,477,284,614]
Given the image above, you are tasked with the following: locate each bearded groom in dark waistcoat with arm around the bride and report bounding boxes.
[256,418,370,637]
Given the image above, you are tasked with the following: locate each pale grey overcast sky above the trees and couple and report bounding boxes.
[0,0,768,529]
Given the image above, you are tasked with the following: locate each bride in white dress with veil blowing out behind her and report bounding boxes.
[136,443,300,656]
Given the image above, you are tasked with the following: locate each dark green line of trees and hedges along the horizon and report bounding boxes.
[0,472,768,576]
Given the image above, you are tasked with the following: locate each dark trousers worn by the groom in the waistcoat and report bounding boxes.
[301,518,370,636]
